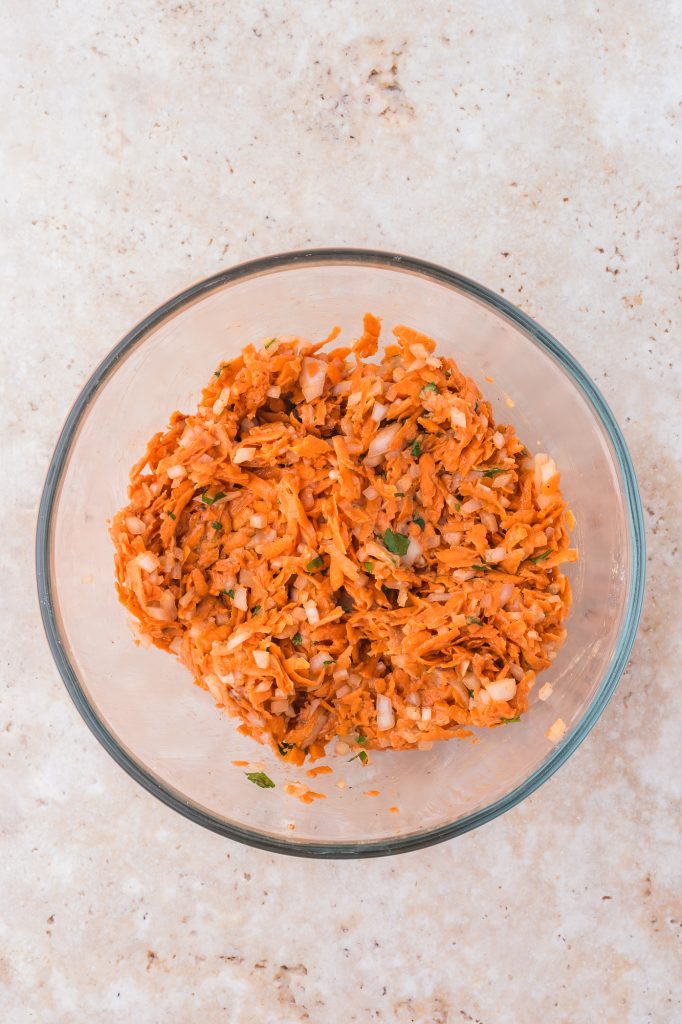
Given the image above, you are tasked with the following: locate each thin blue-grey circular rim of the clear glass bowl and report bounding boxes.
[36,248,646,859]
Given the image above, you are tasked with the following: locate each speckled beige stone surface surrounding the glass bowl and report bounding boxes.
[0,0,682,1024]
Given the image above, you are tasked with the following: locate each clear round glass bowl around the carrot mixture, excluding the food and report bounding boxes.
[37,249,644,857]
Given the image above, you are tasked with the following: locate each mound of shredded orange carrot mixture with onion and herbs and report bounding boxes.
[112,314,577,763]
